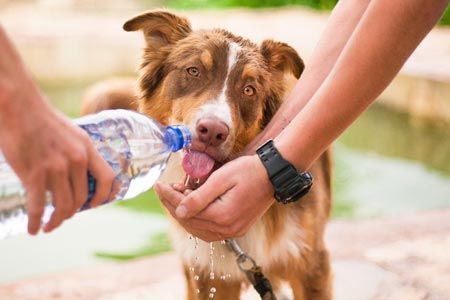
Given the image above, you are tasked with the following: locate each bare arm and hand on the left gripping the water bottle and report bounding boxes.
[0,24,114,234]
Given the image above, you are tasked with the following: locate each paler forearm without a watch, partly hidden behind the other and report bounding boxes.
[247,0,370,153]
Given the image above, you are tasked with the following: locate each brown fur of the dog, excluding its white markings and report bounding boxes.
[83,11,332,300]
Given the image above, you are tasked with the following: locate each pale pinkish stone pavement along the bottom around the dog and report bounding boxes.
[0,209,450,300]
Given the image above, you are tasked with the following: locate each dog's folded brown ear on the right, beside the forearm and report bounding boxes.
[260,40,305,78]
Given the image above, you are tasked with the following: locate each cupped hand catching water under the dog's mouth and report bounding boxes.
[155,155,274,242]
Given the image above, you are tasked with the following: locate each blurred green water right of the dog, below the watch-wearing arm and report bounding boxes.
[333,106,450,217]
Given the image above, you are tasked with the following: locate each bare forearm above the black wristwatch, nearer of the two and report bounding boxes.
[276,0,448,169]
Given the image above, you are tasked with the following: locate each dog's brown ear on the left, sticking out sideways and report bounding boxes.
[123,10,192,49]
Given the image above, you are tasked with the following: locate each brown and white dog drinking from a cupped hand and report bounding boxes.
[84,11,332,300]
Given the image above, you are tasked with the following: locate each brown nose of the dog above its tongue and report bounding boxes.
[196,118,230,147]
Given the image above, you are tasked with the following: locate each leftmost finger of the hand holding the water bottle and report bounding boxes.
[26,176,46,235]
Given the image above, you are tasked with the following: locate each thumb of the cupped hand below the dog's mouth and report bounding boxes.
[175,168,232,219]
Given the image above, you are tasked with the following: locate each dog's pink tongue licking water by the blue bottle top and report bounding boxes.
[183,151,214,178]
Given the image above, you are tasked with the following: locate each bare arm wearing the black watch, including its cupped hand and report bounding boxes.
[156,0,448,239]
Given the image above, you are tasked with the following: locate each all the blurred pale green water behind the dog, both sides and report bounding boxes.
[0,82,450,282]
